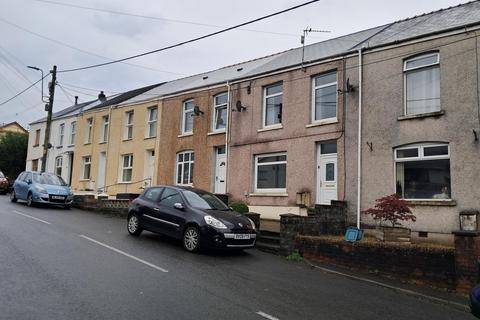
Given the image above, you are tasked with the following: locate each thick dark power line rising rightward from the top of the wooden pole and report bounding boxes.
[58,0,320,73]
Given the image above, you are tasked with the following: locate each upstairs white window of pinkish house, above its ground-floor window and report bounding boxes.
[262,83,283,128]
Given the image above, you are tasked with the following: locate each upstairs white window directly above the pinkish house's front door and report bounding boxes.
[312,71,337,123]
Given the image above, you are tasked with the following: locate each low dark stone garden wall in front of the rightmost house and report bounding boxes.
[295,235,456,290]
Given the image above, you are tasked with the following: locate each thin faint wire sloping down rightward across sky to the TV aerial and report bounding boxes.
[33,0,320,37]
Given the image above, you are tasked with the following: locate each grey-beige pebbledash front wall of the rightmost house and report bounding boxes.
[345,31,480,243]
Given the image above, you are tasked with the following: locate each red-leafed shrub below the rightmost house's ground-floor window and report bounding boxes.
[363,194,417,227]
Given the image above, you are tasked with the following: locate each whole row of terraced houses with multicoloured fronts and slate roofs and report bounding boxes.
[27,1,480,241]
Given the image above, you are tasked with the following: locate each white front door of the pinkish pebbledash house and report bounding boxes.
[316,148,337,204]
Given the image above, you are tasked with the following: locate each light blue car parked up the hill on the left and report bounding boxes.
[10,171,73,209]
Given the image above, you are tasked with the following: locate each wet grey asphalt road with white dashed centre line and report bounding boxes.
[0,196,474,320]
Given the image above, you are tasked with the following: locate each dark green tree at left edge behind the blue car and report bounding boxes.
[0,132,28,179]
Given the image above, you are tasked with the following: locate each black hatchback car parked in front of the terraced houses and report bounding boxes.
[127,186,257,252]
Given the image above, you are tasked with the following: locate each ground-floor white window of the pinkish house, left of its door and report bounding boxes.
[254,152,287,193]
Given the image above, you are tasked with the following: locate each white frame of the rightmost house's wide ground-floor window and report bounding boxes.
[393,143,452,201]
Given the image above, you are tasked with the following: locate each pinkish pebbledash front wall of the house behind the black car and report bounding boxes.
[228,59,345,220]
